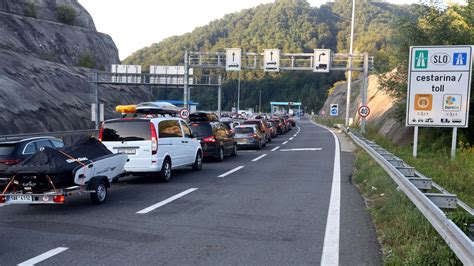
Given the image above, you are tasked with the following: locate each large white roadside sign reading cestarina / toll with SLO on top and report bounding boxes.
[406,45,473,127]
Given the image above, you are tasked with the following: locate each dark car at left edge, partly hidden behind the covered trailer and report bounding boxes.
[0,137,64,183]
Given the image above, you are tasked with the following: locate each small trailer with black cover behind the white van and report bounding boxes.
[0,137,128,207]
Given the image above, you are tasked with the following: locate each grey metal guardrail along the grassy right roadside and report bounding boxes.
[348,132,474,265]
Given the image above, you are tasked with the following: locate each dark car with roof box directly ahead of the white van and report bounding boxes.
[189,114,237,161]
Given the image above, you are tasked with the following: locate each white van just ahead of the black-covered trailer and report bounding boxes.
[99,117,203,182]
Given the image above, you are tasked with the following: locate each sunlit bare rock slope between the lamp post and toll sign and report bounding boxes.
[318,71,413,144]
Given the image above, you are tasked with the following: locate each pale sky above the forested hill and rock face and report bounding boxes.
[79,0,466,59]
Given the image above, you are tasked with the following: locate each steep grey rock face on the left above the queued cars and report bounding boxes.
[0,0,150,134]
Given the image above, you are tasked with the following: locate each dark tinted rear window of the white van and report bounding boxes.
[102,120,151,141]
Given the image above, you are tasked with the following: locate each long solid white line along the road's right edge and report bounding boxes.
[321,123,341,265]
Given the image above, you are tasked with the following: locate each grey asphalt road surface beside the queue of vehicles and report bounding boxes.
[0,121,382,265]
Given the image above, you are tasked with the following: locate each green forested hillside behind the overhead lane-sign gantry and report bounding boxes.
[124,0,413,111]
